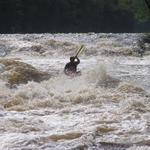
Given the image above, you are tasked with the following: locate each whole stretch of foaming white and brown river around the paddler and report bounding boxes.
[0,33,150,150]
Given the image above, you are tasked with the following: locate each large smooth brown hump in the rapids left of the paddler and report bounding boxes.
[0,59,50,85]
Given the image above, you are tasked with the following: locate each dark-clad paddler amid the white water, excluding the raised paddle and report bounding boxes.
[64,57,80,75]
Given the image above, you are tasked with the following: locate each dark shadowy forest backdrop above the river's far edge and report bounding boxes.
[0,0,150,33]
